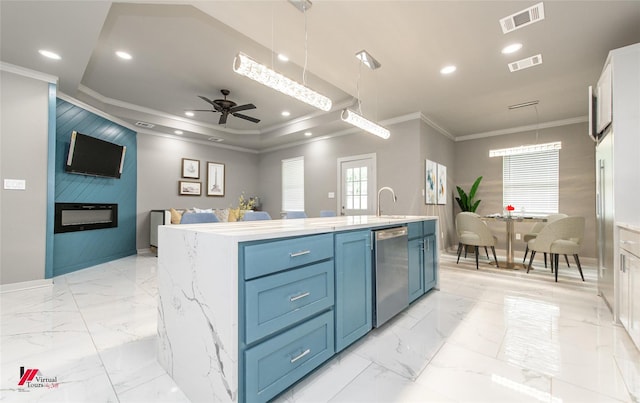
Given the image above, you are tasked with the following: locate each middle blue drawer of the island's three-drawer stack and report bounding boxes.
[245,260,334,344]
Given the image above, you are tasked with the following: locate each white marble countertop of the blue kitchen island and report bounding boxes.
[160,215,438,242]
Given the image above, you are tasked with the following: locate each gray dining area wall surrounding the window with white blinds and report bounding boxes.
[453,123,596,257]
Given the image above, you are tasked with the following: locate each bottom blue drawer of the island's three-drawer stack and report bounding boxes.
[244,311,334,402]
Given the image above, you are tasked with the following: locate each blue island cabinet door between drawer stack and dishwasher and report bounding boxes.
[334,230,373,352]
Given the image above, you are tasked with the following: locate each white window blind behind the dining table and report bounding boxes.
[502,150,559,215]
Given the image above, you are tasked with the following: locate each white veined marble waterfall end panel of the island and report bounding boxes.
[158,230,238,402]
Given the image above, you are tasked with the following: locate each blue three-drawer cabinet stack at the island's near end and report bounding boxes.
[238,234,335,402]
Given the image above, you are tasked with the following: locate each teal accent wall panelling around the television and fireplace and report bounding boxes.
[53,99,138,276]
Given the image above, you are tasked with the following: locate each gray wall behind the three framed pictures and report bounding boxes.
[136,133,259,250]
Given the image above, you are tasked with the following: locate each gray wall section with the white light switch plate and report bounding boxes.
[0,71,49,284]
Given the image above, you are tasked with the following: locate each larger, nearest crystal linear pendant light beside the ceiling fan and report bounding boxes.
[233,53,332,112]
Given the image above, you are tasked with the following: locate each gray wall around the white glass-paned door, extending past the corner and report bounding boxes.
[254,119,455,252]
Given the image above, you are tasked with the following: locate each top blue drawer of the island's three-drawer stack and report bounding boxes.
[242,234,333,280]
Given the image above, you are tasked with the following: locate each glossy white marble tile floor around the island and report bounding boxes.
[0,253,640,403]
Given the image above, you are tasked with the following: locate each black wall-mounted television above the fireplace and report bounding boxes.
[65,131,127,178]
